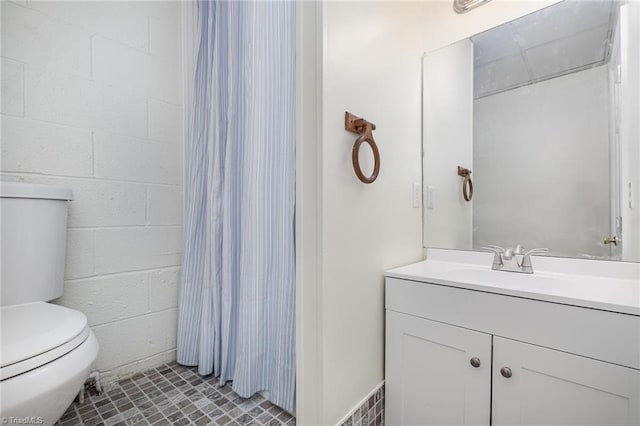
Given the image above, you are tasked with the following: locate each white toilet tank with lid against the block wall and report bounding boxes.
[0,182,73,306]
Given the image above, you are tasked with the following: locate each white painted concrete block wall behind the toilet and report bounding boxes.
[0,0,184,378]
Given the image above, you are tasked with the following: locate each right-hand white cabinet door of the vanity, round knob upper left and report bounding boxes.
[492,336,640,426]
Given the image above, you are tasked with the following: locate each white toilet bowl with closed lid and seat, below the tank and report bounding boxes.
[0,302,98,425]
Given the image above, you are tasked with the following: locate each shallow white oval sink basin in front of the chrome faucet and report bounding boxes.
[446,268,570,289]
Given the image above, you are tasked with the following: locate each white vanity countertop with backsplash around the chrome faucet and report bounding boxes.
[385,249,640,316]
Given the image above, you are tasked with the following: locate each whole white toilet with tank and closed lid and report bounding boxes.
[0,182,98,425]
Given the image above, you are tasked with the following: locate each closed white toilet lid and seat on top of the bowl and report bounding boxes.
[0,302,90,381]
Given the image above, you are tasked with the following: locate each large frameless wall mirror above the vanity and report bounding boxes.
[422,0,640,262]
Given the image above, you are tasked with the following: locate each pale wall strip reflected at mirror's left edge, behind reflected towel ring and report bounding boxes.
[422,39,475,250]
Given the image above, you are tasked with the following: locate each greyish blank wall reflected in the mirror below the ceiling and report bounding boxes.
[473,66,610,258]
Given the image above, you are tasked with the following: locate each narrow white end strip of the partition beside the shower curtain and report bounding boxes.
[296,2,323,425]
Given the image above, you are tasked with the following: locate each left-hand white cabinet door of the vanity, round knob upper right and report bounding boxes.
[385,311,491,426]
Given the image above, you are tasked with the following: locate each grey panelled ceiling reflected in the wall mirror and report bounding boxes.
[471,0,617,98]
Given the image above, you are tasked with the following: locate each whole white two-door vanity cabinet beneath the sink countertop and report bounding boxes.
[385,274,640,426]
